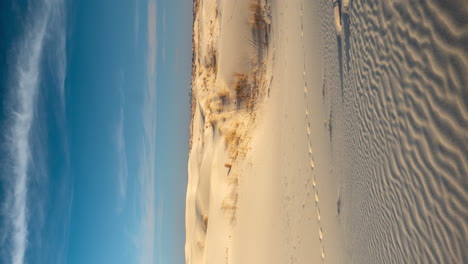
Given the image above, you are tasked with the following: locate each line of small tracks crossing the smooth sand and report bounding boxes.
[300,1,325,262]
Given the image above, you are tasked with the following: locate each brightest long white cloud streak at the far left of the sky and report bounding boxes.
[0,0,65,264]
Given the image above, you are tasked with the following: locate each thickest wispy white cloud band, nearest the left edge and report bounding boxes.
[7,13,47,264]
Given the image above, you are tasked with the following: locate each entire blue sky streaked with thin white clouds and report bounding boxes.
[0,0,192,264]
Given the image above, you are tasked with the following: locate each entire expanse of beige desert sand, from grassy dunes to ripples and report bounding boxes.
[185,0,468,263]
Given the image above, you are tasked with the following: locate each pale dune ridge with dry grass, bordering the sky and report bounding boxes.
[185,0,270,263]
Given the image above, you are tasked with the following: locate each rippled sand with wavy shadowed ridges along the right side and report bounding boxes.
[322,0,468,263]
